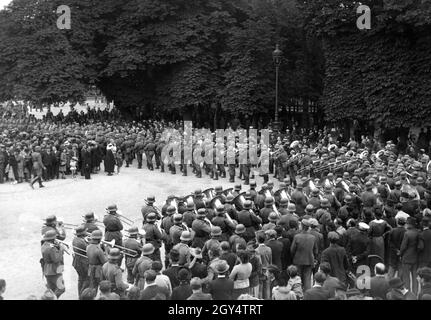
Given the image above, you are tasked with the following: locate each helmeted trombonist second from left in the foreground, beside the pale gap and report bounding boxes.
[72,226,90,296]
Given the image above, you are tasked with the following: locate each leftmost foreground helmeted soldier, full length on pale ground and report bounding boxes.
[40,230,65,298]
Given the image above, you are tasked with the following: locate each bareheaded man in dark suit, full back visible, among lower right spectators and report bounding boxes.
[290,219,319,290]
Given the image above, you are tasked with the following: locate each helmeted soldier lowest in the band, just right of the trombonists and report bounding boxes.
[102,248,129,298]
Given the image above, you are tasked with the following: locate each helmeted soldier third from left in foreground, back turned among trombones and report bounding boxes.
[86,230,107,290]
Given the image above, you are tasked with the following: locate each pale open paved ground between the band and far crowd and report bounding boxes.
[0,163,278,299]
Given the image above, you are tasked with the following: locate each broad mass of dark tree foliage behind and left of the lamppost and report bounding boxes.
[0,0,322,125]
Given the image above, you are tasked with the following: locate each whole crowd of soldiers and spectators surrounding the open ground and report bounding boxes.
[0,103,431,300]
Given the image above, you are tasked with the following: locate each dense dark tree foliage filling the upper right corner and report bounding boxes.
[302,0,431,128]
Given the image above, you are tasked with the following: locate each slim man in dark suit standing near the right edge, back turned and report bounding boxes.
[400,217,419,294]
